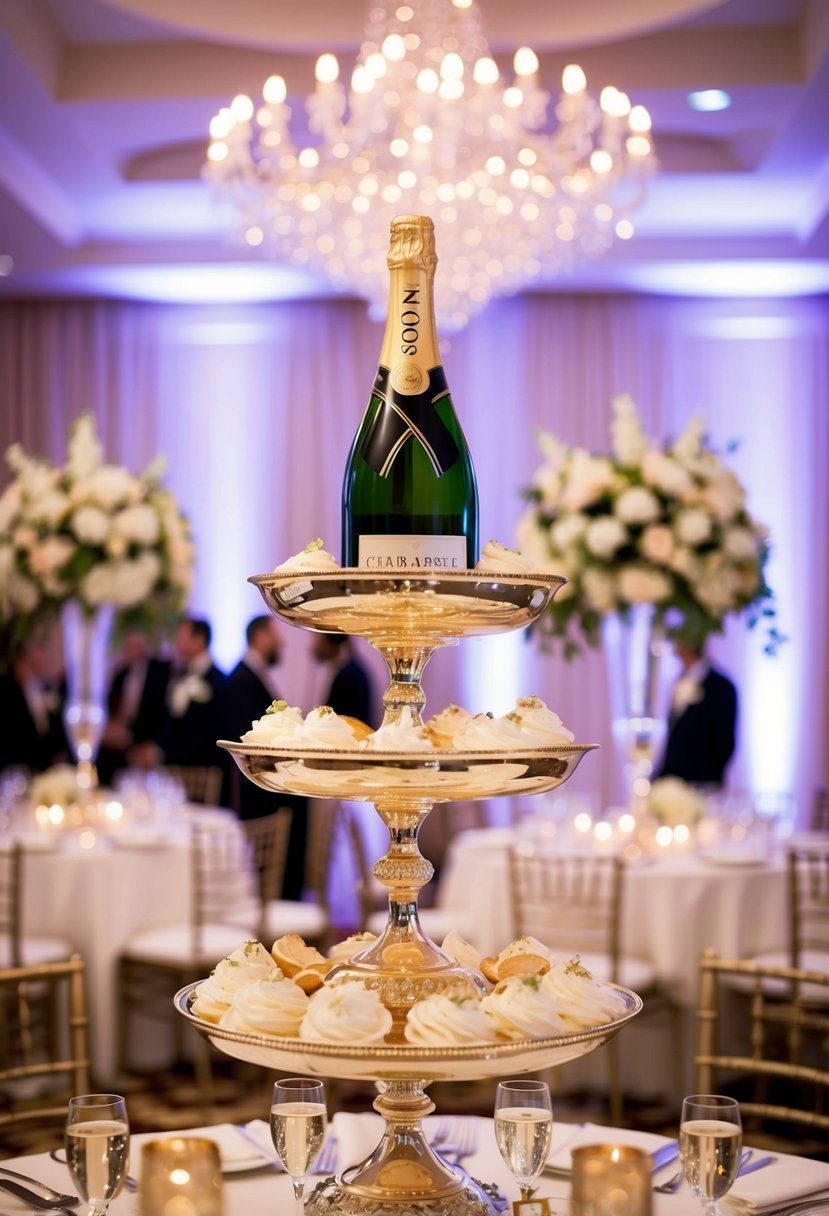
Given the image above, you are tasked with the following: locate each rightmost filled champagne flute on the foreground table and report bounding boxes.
[679,1093,743,1216]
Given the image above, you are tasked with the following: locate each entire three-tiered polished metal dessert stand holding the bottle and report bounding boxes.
[175,569,642,1216]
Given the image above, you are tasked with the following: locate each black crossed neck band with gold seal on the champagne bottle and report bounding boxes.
[362,362,461,477]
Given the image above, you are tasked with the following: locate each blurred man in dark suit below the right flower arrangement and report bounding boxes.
[656,646,738,786]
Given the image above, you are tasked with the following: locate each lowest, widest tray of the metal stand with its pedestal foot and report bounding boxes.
[175,984,642,1216]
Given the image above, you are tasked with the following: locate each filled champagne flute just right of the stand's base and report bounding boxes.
[495,1081,553,1199]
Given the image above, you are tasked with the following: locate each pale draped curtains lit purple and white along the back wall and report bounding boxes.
[0,295,829,821]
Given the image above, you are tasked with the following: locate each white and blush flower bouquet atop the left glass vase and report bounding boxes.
[0,413,194,637]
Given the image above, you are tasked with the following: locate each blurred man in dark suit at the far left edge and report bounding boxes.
[0,636,71,772]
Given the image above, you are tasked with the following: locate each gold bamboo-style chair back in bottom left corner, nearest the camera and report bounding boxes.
[0,955,90,1132]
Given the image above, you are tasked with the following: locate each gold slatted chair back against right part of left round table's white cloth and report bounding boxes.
[190,812,259,959]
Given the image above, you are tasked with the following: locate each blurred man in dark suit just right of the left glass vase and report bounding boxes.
[97,630,170,784]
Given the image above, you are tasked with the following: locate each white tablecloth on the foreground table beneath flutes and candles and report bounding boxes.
[0,1111,829,1216]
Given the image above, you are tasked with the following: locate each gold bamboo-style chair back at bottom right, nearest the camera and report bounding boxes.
[694,951,829,1143]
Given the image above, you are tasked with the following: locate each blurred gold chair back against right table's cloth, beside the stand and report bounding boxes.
[509,843,624,981]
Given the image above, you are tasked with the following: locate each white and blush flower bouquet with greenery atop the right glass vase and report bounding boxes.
[518,395,780,658]
